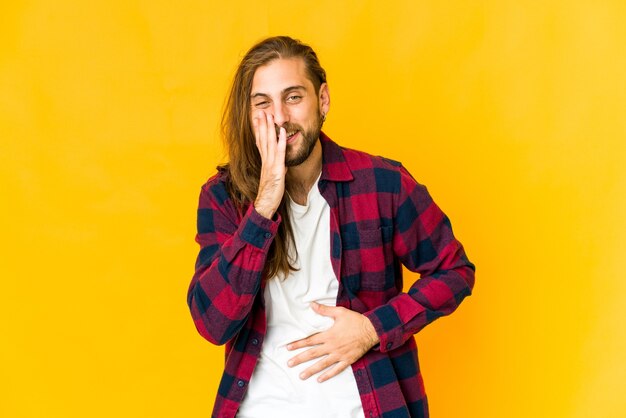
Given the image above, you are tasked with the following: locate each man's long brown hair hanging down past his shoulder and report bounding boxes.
[222,36,326,278]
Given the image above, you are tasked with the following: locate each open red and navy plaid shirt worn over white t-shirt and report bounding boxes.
[188,133,474,418]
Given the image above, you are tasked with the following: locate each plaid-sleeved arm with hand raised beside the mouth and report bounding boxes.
[187,112,286,344]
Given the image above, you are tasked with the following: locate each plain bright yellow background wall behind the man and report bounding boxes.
[0,0,626,418]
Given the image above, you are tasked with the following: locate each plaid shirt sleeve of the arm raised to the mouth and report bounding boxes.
[187,178,281,344]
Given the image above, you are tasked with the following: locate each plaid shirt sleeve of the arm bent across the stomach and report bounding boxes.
[365,167,475,352]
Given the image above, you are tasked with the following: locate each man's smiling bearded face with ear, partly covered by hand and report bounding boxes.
[250,58,330,167]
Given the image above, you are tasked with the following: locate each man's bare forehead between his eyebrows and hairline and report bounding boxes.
[250,58,313,95]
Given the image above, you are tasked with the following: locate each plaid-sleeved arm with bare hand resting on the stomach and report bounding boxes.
[288,167,474,382]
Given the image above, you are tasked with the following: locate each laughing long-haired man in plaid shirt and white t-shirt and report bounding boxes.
[188,37,474,418]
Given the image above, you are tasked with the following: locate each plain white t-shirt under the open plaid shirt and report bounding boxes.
[237,177,364,418]
